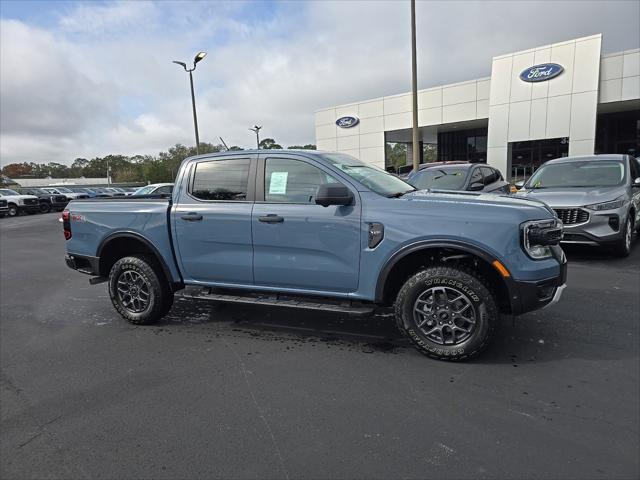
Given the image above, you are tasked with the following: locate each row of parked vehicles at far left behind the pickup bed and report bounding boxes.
[0,183,173,218]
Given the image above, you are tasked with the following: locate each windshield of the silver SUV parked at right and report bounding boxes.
[525,160,624,189]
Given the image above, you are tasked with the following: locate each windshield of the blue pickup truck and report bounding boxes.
[323,153,416,197]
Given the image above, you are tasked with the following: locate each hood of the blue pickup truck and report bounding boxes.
[401,190,554,216]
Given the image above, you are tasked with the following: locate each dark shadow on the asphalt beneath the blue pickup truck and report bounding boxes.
[152,300,633,367]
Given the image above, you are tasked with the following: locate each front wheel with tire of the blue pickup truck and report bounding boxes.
[395,266,499,360]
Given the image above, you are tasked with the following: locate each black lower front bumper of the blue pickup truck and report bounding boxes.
[507,247,567,315]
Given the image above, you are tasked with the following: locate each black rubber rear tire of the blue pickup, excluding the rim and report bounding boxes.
[109,255,173,325]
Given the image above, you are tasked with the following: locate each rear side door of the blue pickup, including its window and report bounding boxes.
[172,155,257,285]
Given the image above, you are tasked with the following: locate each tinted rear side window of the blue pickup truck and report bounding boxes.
[191,158,250,201]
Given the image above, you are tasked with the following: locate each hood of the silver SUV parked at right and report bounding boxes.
[515,187,625,207]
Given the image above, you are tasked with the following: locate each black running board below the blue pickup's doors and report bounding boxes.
[176,288,375,315]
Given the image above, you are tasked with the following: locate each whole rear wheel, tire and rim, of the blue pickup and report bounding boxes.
[109,255,173,325]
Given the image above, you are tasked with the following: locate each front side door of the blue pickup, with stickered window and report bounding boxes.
[252,154,361,292]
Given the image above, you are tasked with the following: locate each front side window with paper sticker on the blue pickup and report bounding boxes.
[264,158,339,203]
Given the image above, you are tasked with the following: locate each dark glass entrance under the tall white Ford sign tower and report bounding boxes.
[509,137,569,182]
